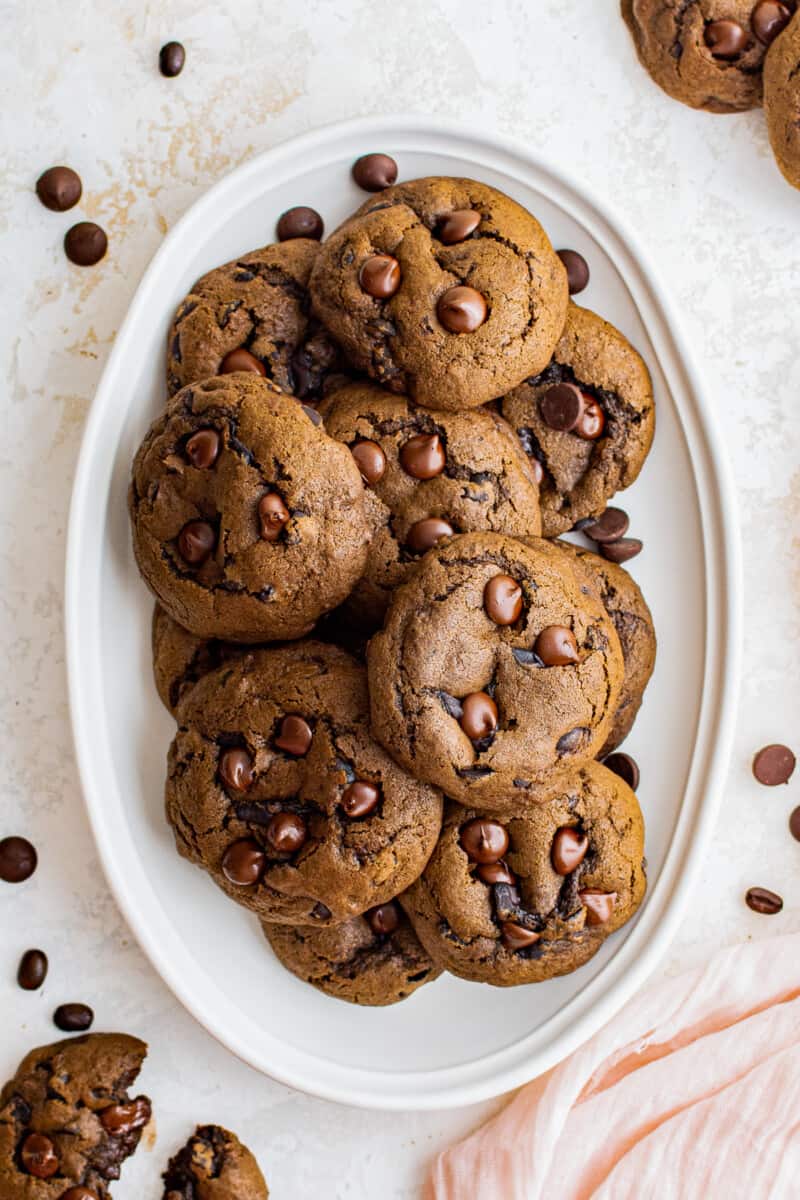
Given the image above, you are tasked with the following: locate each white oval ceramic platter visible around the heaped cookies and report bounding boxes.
[67,119,739,1109]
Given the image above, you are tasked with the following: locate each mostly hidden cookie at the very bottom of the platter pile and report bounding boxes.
[263,900,441,1007]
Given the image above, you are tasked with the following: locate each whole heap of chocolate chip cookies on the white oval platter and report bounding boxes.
[130,155,655,1004]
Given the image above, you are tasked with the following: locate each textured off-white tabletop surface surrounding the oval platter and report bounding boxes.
[0,0,800,1200]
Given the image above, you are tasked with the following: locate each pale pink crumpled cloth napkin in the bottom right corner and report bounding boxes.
[426,934,800,1200]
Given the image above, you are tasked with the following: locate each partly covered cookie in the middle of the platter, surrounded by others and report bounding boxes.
[320,383,541,626]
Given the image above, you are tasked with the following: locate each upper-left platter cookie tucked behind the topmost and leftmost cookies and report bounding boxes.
[167,238,342,400]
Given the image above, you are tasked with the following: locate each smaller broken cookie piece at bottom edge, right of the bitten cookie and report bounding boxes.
[163,1126,270,1200]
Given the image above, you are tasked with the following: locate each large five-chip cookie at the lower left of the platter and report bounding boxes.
[167,642,441,925]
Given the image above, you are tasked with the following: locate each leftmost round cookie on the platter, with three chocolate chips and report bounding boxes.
[130,372,369,642]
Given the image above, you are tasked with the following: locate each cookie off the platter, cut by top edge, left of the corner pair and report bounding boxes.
[621,0,766,113]
